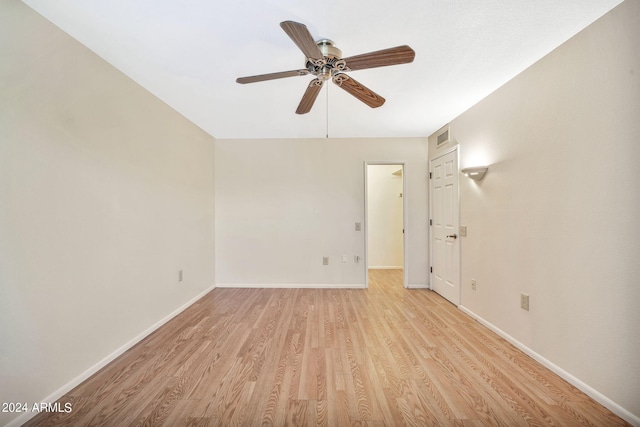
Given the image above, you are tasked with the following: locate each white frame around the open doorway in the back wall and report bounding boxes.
[364,161,409,288]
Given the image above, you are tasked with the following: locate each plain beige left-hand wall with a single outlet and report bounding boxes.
[0,0,215,425]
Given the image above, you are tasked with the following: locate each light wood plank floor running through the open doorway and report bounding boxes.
[26,270,626,427]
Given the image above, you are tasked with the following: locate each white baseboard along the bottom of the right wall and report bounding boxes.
[458,305,640,427]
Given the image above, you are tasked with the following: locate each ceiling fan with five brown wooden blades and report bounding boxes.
[236,21,416,114]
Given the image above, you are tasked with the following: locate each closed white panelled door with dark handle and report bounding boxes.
[429,149,460,305]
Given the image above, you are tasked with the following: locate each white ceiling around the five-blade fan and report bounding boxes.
[24,0,621,138]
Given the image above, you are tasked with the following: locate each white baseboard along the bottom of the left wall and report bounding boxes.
[5,285,216,427]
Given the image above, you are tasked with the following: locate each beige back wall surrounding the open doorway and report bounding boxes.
[216,138,428,287]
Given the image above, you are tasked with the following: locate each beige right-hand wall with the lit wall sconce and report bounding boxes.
[430,0,640,423]
